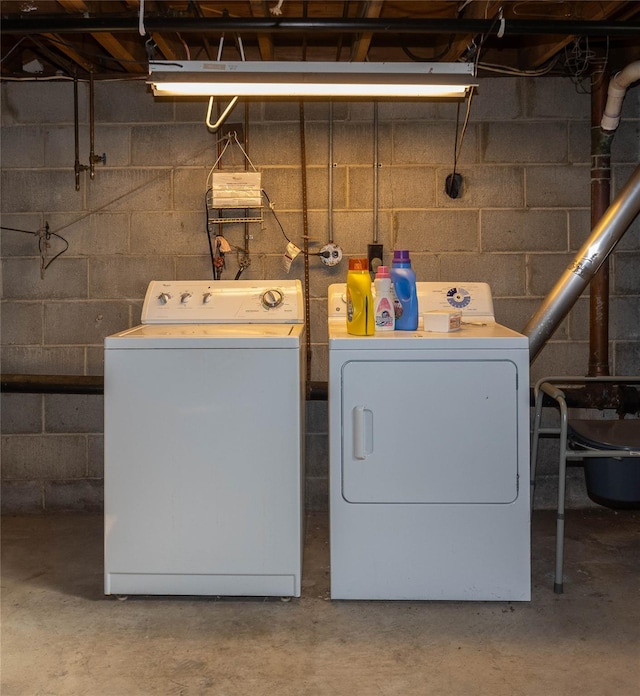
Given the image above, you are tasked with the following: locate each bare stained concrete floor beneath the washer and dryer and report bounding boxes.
[1,508,640,696]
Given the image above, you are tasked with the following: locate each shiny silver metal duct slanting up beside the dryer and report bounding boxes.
[522,166,640,363]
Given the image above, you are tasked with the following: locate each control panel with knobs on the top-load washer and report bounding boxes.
[142,280,304,324]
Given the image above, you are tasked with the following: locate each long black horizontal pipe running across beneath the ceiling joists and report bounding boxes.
[0,16,640,36]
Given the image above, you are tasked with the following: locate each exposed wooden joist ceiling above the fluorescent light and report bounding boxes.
[0,0,640,77]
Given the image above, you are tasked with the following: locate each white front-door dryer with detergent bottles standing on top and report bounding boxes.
[329,283,531,600]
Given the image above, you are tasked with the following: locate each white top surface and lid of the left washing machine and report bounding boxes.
[104,324,304,350]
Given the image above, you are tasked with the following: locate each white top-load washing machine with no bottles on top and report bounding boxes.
[105,280,305,597]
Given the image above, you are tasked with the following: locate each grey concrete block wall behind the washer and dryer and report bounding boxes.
[0,77,640,512]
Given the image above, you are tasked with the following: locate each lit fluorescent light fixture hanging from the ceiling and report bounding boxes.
[147,60,477,99]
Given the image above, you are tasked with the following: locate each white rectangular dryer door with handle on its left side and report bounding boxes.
[342,362,518,504]
